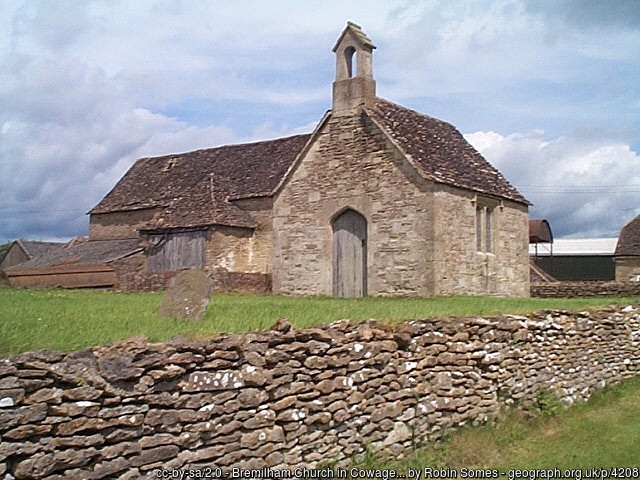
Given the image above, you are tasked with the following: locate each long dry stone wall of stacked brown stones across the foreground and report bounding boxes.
[0,305,640,480]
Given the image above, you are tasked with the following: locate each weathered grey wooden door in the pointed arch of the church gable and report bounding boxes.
[333,210,367,297]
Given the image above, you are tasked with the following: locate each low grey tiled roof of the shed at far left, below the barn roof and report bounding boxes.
[7,239,140,272]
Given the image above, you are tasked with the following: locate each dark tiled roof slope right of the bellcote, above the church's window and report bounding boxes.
[369,98,529,204]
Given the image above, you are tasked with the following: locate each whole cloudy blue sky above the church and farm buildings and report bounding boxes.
[0,0,640,242]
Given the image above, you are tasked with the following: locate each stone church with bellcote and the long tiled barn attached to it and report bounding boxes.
[12,23,529,297]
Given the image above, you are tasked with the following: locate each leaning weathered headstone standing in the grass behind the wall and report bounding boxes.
[158,269,213,320]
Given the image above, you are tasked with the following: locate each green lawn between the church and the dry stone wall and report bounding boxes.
[0,287,639,356]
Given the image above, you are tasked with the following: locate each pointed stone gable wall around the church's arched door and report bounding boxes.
[273,113,434,295]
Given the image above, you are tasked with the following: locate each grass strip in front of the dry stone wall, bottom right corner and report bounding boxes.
[348,377,640,478]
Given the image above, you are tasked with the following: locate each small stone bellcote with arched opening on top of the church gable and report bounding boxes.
[332,22,376,113]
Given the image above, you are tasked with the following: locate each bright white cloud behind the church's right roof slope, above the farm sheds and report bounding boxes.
[465,130,640,237]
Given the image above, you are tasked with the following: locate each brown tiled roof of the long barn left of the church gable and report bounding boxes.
[90,135,310,228]
